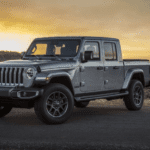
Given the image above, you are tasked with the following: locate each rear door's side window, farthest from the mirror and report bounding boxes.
[104,42,117,60]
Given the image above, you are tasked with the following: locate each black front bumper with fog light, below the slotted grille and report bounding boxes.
[0,87,44,108]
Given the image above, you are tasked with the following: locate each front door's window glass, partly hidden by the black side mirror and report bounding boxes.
[84,42,100,60]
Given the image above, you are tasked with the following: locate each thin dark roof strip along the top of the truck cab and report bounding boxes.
[35,36,119,41]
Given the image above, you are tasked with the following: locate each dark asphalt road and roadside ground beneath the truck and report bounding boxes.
[0,99,150,150]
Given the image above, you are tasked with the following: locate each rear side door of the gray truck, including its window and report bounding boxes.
[102,41,124,91]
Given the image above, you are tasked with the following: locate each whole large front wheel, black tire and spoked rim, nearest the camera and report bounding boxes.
[34,83,74,124]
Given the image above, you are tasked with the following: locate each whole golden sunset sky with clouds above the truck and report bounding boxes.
[0,0,150,60]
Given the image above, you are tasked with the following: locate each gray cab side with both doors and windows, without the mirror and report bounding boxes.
[78,38,124,92]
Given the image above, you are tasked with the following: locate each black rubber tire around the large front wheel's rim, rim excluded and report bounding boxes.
[34,83,74,124]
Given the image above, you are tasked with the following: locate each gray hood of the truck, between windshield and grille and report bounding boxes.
[0,59,77,71]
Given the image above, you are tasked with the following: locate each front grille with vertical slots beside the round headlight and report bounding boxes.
[0,67,24,86]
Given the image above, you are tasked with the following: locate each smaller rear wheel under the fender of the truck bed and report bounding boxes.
[124,80,144,110]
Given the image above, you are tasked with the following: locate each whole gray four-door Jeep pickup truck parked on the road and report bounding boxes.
[0,37,150,124]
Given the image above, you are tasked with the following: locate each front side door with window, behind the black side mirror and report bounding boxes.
[80,41,104,92]
